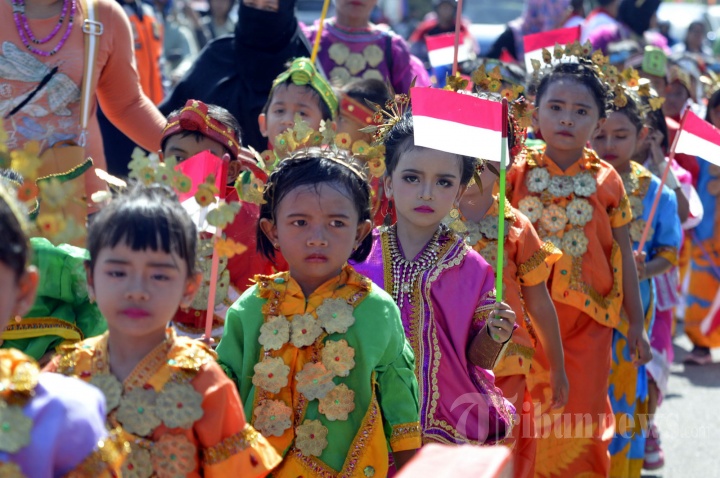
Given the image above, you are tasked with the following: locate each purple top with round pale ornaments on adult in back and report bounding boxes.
[303,18,430,94]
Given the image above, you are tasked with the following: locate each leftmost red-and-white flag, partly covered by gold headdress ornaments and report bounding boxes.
[175,151,228,234]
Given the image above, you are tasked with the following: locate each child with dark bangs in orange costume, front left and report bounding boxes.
[47,186,280,477]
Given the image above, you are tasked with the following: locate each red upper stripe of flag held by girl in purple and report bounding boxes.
[410,87,502,132]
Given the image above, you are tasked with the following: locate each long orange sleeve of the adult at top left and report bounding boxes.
[96,0,166,152]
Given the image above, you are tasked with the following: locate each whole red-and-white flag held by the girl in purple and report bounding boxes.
[410,87,503,162]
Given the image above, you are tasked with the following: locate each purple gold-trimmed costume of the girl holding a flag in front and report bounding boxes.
[354,230,515,444]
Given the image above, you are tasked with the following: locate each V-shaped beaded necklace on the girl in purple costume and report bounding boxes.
[387,224,447,307]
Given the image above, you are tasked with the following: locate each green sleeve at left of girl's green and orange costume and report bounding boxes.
[216,286,265,408]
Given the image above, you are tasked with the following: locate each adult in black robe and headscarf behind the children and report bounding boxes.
[160,0,310,151]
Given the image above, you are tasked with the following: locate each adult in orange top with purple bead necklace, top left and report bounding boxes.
[0,0,165,197]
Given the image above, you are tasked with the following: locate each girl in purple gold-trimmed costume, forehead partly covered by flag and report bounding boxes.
[356,106,515,444]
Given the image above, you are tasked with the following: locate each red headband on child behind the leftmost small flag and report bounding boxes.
[162,100,240,160]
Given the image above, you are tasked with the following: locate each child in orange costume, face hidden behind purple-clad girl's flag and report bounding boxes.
[450,104,568,477]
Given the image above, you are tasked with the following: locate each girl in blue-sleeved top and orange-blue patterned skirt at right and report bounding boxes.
[592,84,681,478]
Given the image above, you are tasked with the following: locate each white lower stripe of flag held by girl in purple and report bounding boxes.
[413,116,502,162]
